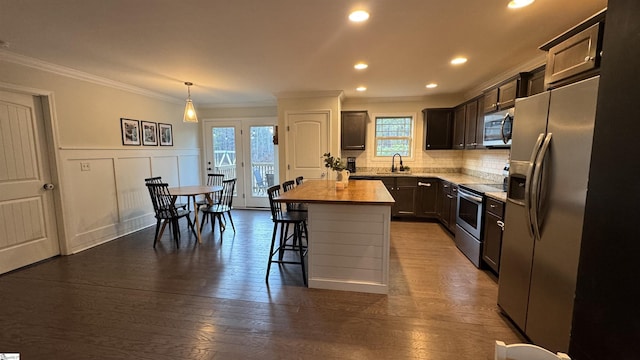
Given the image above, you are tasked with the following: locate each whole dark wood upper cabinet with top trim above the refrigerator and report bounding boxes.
[540,11,605,89]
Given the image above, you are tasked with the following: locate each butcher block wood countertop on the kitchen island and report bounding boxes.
[274,180,395,206]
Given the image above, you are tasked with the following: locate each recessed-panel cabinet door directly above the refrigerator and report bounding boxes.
[545,23,601,85]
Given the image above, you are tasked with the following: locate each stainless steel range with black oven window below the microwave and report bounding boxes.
[455,184,503,268]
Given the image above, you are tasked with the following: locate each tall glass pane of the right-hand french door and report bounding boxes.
[249,125,275,196]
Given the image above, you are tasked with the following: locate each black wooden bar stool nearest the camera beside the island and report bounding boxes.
[265,185,308,286]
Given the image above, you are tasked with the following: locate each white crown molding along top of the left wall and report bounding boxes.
[0,50,184,104]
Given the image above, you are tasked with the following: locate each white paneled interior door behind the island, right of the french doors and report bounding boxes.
[287,112,329,179]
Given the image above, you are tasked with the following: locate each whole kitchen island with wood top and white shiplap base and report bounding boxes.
[275,180,395,294]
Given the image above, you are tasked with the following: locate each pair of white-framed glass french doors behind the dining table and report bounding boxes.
[204,118,279,207]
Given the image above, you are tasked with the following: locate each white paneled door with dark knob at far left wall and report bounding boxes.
[0,91,60,273]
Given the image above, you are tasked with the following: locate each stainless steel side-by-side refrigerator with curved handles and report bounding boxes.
[498,77,599,352]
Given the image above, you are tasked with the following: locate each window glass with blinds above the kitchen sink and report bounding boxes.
[375,117,413,156]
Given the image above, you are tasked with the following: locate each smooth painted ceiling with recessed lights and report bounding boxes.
[0,0,607,106]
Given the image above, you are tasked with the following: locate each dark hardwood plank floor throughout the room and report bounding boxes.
[0,210,523,360]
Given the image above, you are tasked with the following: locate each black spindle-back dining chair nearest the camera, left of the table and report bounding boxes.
[146,183,198,249]
